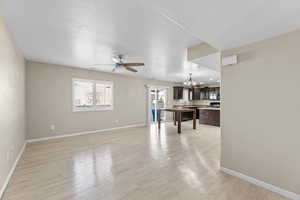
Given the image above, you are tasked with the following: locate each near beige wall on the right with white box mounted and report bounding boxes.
[221,28,300,194]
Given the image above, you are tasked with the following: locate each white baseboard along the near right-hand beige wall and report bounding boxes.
[220,167,300,200]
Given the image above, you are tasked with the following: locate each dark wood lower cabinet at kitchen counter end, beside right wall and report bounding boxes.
[199,109,220,126]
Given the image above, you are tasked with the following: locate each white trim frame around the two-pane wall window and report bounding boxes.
[72,78,114,112]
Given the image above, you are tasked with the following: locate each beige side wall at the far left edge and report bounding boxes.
[0,17,25,195]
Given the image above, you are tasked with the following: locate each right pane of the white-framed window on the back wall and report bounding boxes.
[96,83,112,106]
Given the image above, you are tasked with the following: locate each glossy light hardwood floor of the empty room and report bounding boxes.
[3,123,285,200]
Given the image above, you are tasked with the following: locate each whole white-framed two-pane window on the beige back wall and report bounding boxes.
[73,79,113,112]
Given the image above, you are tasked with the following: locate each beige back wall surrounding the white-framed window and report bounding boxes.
[26,62,173,139]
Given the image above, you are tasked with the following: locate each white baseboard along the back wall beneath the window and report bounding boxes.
[27,124,146,143]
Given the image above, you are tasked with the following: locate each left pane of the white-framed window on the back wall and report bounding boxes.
[74,81,93,107]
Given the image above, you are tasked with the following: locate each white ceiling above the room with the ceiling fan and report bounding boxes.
[0,0,300,82]
